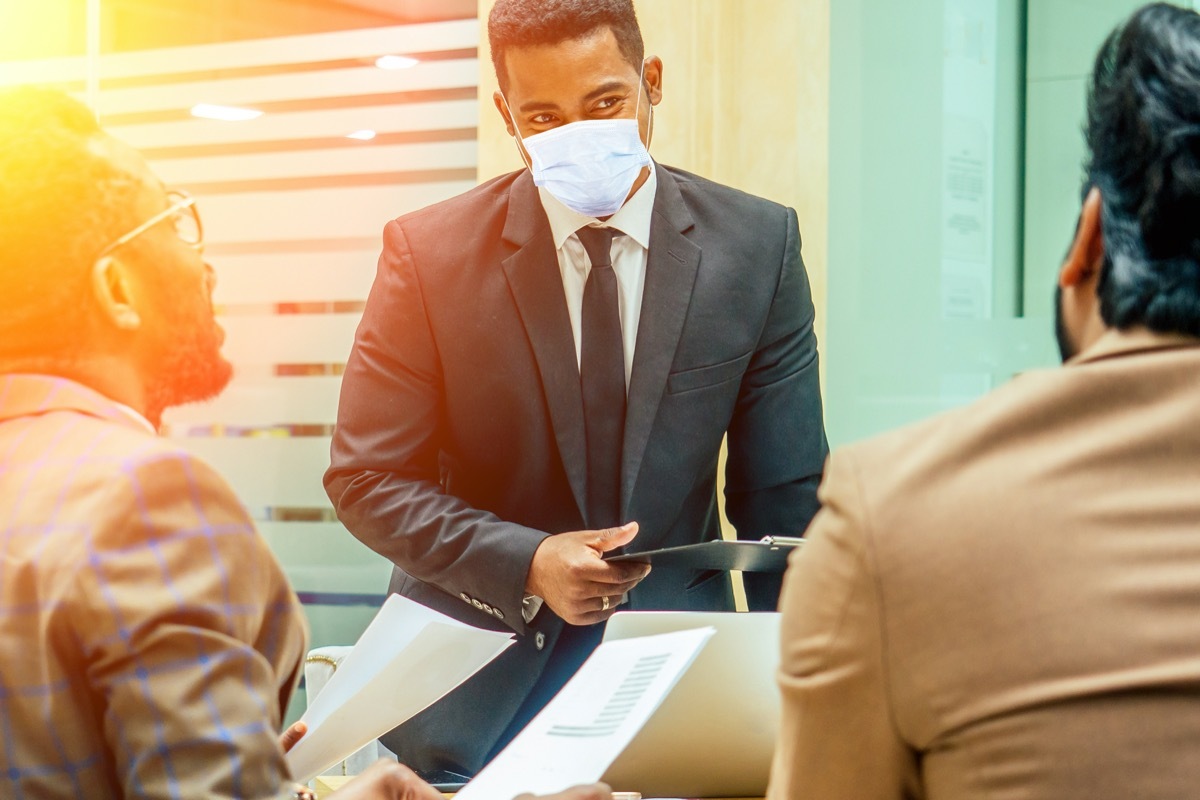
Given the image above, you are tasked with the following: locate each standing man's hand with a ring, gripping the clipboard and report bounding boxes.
[526,522,650,625]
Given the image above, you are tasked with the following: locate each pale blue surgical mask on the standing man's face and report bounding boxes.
[504,66,654,217]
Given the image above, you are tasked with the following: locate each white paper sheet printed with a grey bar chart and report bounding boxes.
[455,627,715,800]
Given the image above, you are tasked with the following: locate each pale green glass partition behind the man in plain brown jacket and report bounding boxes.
[826,0,1195,445]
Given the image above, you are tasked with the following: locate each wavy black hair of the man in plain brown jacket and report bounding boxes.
[1084,2,1200,336]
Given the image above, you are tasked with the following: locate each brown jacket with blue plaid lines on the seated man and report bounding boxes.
[0,375,306,800]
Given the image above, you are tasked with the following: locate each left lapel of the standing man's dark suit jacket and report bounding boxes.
[503,172,587,518]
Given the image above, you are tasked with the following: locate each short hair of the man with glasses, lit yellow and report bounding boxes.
[0,88,137,365]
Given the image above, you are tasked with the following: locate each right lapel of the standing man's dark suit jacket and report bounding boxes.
[620,166,700,519]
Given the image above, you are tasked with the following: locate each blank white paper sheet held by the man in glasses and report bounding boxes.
[287,595,514,782]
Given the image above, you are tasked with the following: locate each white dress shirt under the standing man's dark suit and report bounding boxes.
[521,162,659,622]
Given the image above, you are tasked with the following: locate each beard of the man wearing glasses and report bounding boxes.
[146,278,233,427]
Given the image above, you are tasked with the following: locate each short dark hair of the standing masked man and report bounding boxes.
[487,0,646,91]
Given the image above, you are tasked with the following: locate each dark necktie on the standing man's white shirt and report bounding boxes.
[576,227,625,530]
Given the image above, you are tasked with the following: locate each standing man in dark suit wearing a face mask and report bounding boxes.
[325,0,827,774]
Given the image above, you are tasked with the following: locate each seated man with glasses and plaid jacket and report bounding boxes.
[0,89,607,800]
